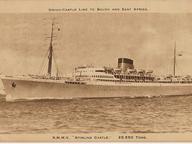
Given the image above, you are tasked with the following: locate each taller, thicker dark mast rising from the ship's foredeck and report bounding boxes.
[47,22,54,77]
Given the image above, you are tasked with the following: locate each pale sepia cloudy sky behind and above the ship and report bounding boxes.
[0,13,192,75]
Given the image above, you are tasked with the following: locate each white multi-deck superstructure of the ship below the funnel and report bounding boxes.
[74,67,154,82]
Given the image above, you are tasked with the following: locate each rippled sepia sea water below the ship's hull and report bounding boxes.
[0,96,192,134]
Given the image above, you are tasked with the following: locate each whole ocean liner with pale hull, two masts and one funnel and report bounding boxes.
[1,23,192,101]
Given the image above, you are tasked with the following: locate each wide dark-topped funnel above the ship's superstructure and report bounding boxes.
[118,58,134,72]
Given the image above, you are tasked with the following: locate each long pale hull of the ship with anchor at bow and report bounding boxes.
[2,78,192,101]
